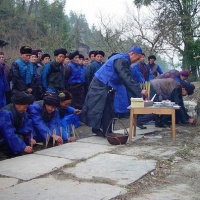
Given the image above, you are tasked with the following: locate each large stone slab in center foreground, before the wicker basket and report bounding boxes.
[64,153,156,185]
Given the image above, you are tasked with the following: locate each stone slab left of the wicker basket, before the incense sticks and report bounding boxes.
[36,142,116,160]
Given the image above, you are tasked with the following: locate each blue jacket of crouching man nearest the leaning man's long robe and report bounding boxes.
[58,106,80,141]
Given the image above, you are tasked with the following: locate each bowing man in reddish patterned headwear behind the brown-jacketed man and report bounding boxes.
[156,69,190,83]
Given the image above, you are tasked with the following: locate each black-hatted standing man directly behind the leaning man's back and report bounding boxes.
[85,51,105,89]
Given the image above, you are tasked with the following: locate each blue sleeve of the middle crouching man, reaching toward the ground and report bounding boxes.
[27,103,52,141]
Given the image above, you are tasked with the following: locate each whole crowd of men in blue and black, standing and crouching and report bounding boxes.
[0,46,195,155]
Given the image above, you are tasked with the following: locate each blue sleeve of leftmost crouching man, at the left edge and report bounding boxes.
[0,110,26,155]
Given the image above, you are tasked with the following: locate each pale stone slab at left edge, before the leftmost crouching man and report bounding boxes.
[0,154,72,180]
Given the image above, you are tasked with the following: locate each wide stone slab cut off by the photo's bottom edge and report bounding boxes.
[0,176,126,200]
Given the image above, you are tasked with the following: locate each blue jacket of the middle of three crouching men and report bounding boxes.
[27,100,60,142]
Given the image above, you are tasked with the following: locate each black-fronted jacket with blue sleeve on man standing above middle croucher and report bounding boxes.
[41,60,65,92]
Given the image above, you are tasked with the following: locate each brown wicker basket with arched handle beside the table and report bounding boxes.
[106,118,128,145]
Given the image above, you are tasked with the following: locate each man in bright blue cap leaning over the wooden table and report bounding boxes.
[81,46,147,137]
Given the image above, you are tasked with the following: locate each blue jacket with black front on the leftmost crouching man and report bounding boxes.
[0,104,34,155]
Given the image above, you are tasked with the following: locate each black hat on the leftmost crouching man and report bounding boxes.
[11,91,34,105]
